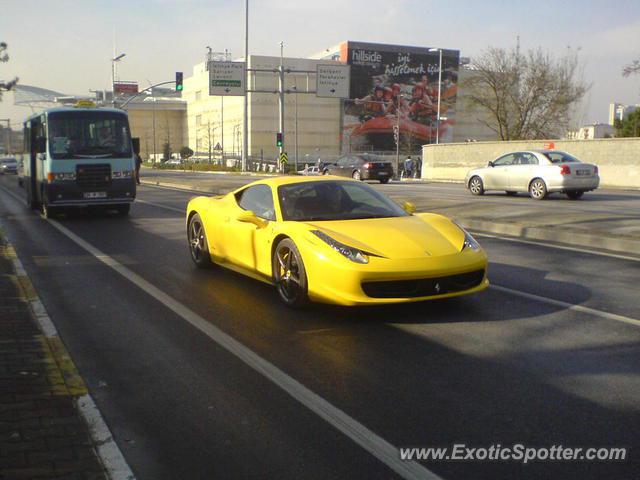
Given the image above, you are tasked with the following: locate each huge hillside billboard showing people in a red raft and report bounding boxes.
[339,42,460,154]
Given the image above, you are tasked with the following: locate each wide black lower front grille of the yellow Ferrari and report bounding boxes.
[362,270,484,298]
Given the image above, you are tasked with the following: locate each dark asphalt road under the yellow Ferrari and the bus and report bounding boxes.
[0,173,640,479]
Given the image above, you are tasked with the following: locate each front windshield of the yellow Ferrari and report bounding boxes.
[278,180,408,222]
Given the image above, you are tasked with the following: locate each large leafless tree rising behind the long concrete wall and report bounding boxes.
[463,47,589,140]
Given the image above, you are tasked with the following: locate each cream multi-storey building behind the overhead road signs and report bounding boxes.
[183,55,340,164]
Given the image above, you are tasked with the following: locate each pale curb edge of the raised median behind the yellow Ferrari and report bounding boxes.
[142,180,640,253]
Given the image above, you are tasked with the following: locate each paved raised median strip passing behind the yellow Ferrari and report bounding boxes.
[142,174,640,256]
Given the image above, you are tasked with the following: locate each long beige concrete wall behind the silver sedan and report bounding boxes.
[422,138,640,188]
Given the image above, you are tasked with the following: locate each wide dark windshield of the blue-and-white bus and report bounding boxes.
[48,110,132,159]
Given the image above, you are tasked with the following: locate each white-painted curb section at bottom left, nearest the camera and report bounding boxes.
[76,395,135,480]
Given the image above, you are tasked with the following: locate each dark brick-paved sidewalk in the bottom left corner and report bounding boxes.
[0,231,109,480]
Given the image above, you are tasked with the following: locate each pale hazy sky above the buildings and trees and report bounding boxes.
[0,0,640,127]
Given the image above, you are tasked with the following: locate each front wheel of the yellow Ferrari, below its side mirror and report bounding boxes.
[271,238,309,308]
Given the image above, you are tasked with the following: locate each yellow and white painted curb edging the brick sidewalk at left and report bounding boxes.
[0,228,135,480]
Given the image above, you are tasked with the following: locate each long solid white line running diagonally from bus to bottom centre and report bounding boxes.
[43,220,440,480]
